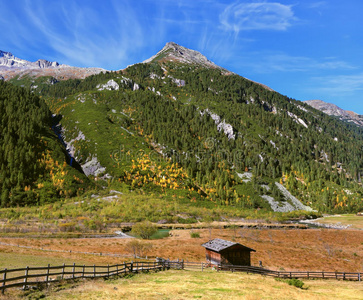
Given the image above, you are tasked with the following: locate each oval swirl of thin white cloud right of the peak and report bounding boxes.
[219,2,296,34]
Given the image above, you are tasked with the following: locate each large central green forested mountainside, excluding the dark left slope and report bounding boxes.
[39,57,363,212]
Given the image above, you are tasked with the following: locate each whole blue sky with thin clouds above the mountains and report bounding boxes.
[0,0,363,114]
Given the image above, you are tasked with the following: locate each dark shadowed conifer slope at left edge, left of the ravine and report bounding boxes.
[0,81,88,207]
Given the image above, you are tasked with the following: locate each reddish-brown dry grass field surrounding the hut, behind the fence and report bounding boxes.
[0,228,363,272]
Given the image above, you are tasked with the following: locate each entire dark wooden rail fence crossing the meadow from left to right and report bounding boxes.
[0,259,362,294]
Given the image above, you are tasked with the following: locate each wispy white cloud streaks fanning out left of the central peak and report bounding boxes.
[0,0,154,69]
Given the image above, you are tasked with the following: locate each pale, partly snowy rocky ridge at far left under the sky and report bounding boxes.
[0,50,105,80]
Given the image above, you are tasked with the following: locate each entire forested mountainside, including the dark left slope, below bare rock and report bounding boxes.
[0,59,363,213]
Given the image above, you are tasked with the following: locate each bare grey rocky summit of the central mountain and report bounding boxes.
[143,42,228,72]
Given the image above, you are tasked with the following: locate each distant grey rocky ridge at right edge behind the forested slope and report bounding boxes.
[304,100,363,126]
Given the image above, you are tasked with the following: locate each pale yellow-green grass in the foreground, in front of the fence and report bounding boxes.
[4,270,363,300]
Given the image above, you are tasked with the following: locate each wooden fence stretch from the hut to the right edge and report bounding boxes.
[217,265,362,281]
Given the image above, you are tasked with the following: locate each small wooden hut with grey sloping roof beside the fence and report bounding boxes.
[202,239,256,266]
